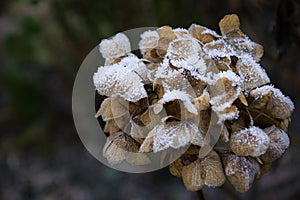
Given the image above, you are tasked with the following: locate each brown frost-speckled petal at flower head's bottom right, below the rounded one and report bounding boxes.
[223,154,260,192]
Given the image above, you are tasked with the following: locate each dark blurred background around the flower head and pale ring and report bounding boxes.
[0,0,300,200]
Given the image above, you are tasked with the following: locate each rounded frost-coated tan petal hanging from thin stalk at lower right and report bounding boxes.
[230,126,270,157]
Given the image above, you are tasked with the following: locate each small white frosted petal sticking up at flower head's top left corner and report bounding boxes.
[99,33,131,59]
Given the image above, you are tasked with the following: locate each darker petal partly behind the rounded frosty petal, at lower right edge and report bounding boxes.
[261,125,290,163]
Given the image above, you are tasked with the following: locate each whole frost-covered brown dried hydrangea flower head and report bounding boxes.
[93,15,294,192]
